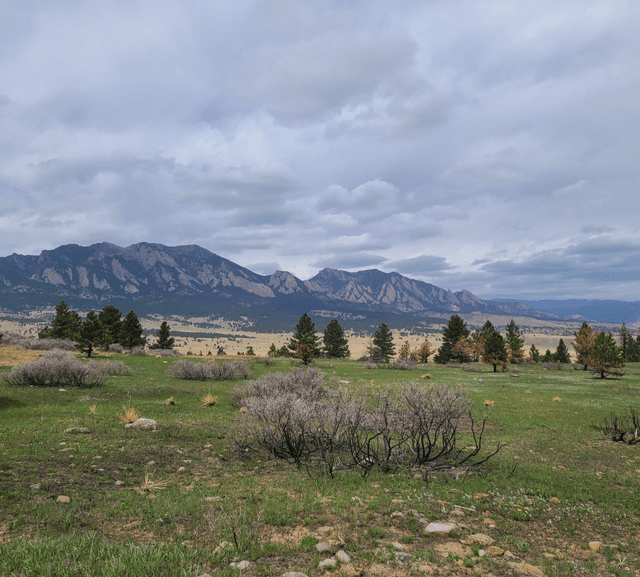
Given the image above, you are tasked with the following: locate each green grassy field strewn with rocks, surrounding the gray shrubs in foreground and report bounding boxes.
[0,347,640,577]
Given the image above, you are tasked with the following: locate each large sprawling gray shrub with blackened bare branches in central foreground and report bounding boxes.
[230,373,501,480]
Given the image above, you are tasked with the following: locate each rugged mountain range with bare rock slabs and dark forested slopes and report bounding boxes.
[0,242,558,320]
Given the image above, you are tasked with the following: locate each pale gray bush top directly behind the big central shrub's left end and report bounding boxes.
[229,367,326,409]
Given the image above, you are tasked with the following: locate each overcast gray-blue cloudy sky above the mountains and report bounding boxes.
[0,0,640,301]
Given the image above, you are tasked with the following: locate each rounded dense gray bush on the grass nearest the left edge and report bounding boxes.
[4,350,107,389]
